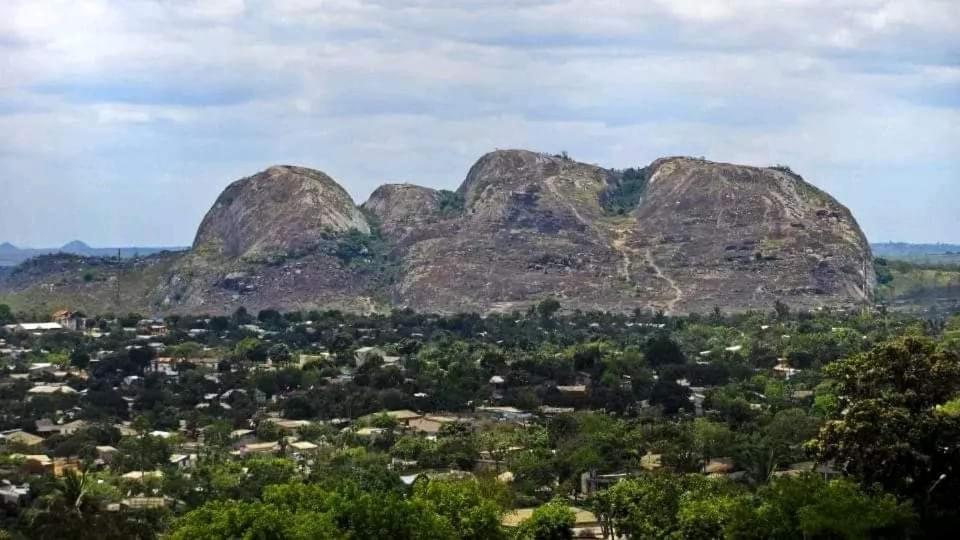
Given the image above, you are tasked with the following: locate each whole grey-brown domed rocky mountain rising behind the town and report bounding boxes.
[0,150,875,313]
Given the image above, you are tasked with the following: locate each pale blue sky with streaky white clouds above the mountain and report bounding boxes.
[0,0,960,247]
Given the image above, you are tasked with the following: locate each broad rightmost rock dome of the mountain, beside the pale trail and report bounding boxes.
[623,158,875,312]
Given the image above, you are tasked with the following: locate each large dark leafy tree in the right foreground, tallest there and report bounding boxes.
[816,336,960,532]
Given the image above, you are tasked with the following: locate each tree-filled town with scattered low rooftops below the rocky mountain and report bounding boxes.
[0,300,960,538]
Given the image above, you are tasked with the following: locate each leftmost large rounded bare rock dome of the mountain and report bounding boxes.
[193,166,370,259]
